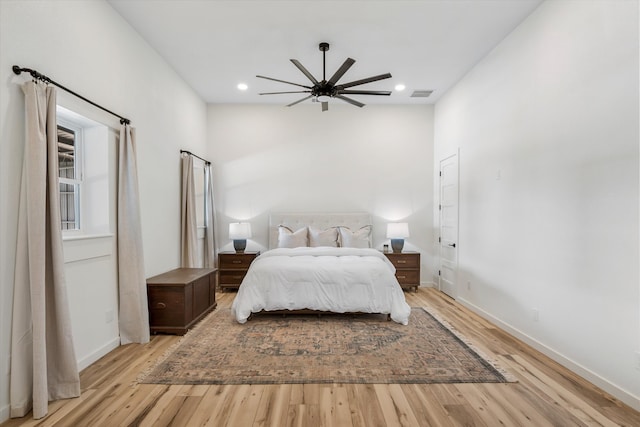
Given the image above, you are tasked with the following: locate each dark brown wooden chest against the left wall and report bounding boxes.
[147,268,217,335]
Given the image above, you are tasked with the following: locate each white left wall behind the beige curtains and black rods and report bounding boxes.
[0,0,207,421]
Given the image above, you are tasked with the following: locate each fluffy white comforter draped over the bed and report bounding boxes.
[231,247,411,325]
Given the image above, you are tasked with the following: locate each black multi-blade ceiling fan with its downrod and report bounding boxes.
[256,42,391,111]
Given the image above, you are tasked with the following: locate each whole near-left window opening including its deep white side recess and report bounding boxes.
[57,105,110,238]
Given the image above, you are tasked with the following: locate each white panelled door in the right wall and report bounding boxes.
[438,154,458,298]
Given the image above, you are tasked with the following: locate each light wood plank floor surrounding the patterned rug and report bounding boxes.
[2,289,640,427]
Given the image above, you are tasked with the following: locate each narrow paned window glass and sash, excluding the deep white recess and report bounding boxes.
[58,124,82,230]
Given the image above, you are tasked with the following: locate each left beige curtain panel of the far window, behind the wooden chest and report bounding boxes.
[180,154,198,268]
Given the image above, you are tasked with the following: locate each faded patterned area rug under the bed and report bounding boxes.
[139,308,512,384]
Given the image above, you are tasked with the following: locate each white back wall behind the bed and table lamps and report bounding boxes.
[208,102,433,282]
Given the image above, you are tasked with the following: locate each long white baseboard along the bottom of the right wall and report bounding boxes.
[456,298,640,411]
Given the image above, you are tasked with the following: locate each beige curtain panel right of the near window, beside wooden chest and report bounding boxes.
[118,124,149,344]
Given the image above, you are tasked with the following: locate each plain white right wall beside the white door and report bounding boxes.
[435,1,640,409]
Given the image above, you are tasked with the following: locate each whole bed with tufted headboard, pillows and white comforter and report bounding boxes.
[231,213,411,325]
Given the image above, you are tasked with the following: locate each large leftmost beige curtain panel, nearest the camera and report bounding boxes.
[10,82,80,419]
